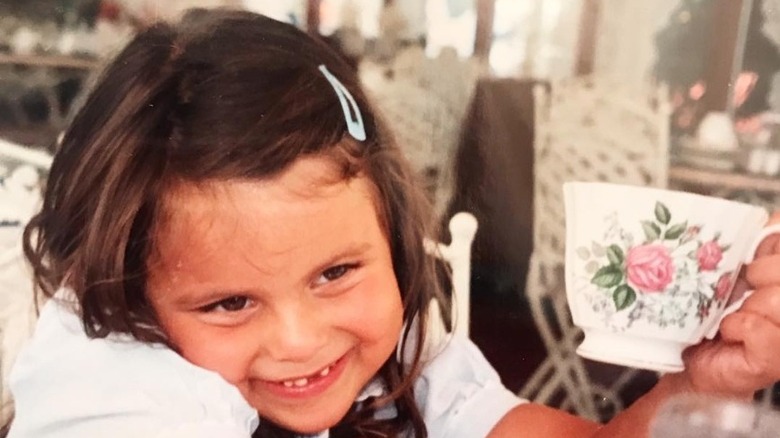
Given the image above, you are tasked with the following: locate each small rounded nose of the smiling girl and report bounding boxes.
[265,304,327,362]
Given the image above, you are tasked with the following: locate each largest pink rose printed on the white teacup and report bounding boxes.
[626,244,674,292]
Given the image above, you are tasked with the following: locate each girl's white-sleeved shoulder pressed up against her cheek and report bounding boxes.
[9,300,257,438]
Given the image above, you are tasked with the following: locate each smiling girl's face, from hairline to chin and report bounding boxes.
[143,158,402,433]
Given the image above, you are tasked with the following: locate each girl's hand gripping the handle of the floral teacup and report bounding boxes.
[683,213,780,398]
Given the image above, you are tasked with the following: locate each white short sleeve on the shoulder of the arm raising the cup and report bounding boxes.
[415,336,524,438]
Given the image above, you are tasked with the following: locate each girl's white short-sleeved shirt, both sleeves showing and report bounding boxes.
[9,294,522,438]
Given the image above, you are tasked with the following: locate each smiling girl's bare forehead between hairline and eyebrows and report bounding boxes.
[148,161,387,280]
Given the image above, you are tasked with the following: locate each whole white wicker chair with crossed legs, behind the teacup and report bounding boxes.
[519,77,670,420]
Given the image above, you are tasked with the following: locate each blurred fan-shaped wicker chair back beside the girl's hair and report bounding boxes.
[360,47,479,217]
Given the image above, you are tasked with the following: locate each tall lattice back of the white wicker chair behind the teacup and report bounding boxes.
[533,77,671,263]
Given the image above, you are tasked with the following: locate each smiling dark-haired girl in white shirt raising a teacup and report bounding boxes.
[10,10,780,438]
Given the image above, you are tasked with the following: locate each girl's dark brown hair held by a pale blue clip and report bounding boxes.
[25,10,439,437]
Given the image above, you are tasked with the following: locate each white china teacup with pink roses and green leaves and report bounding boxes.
[563,182,780,372]
